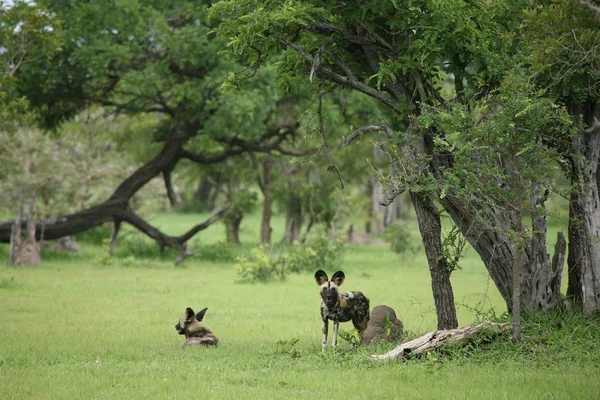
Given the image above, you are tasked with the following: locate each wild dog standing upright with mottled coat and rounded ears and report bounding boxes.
[315,270,369,351]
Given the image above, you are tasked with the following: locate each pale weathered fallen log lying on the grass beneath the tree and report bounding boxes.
[370,321,510,361]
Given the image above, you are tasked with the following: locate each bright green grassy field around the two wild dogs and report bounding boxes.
[0,214,600,399]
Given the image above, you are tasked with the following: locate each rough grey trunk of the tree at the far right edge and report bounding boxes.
[567,101,600,315]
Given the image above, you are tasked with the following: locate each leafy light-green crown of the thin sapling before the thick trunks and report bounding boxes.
[420,66,571,230]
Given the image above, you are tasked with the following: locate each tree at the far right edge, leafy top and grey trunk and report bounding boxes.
[525,0,600,315]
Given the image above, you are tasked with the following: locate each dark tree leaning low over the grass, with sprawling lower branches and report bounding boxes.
[0,1,310,262]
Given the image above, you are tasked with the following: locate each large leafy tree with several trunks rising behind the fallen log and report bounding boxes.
[212,0,580,329]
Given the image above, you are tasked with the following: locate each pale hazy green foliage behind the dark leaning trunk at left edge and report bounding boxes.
[0,121,164,218]
